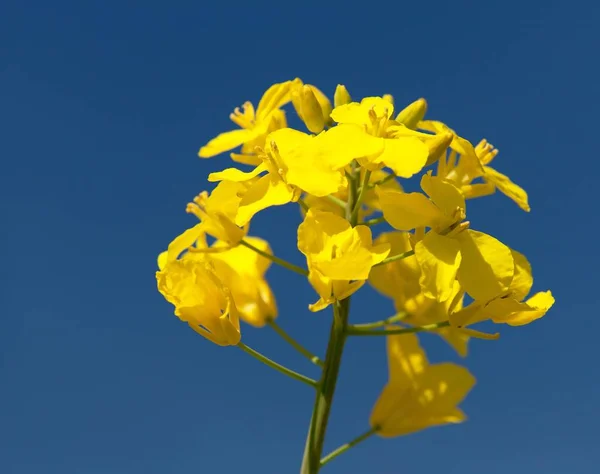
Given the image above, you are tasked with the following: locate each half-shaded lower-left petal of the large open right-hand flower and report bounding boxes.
[415,231,461,302]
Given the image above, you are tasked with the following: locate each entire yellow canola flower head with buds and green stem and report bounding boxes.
[156,78,554,474]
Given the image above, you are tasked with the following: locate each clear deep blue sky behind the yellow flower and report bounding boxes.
[0,0,600,474]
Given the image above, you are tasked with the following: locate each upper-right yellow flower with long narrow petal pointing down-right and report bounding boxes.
[434,131,531,212]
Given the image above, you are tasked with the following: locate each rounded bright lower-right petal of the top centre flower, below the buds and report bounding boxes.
[373,137,429,178]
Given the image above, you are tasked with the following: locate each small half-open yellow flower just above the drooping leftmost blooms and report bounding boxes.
[186,181,248,246]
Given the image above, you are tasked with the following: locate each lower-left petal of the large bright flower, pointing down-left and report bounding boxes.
[235,174,294,226]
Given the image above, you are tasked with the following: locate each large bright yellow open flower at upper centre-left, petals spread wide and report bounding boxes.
[208,125,381,226]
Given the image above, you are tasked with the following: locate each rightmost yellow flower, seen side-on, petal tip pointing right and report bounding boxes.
[450,250,554,327]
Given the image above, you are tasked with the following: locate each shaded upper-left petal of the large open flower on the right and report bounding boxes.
[376,187,444,231]
